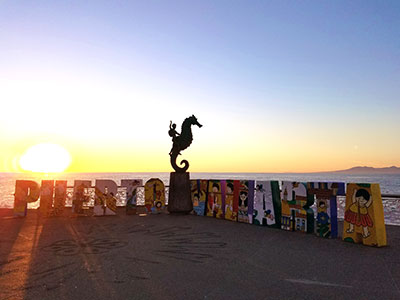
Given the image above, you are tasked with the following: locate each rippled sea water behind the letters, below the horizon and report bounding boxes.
[0,172,400,225]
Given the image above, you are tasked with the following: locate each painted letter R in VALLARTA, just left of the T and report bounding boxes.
[281,181,314,233]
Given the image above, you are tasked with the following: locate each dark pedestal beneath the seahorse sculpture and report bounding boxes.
[168,172,193,214]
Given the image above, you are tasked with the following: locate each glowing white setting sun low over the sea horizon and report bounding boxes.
[19,144,71,173]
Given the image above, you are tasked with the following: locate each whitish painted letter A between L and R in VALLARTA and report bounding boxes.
[253,181,281,228]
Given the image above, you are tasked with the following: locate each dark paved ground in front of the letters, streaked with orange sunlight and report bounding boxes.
[0,209,400,300]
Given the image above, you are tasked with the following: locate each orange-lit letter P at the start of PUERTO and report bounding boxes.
[14,180,40,217]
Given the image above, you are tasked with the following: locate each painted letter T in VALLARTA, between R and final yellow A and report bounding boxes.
[307,182,345,238]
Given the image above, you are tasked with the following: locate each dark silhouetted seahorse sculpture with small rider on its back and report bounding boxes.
[168,115,203,173]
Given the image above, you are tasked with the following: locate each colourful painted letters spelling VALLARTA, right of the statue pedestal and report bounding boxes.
[191,180,387,247]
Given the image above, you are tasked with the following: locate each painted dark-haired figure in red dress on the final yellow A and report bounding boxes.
[344,189,373,238]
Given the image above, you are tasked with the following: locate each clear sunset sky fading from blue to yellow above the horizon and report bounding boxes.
[0,0,400,172]
